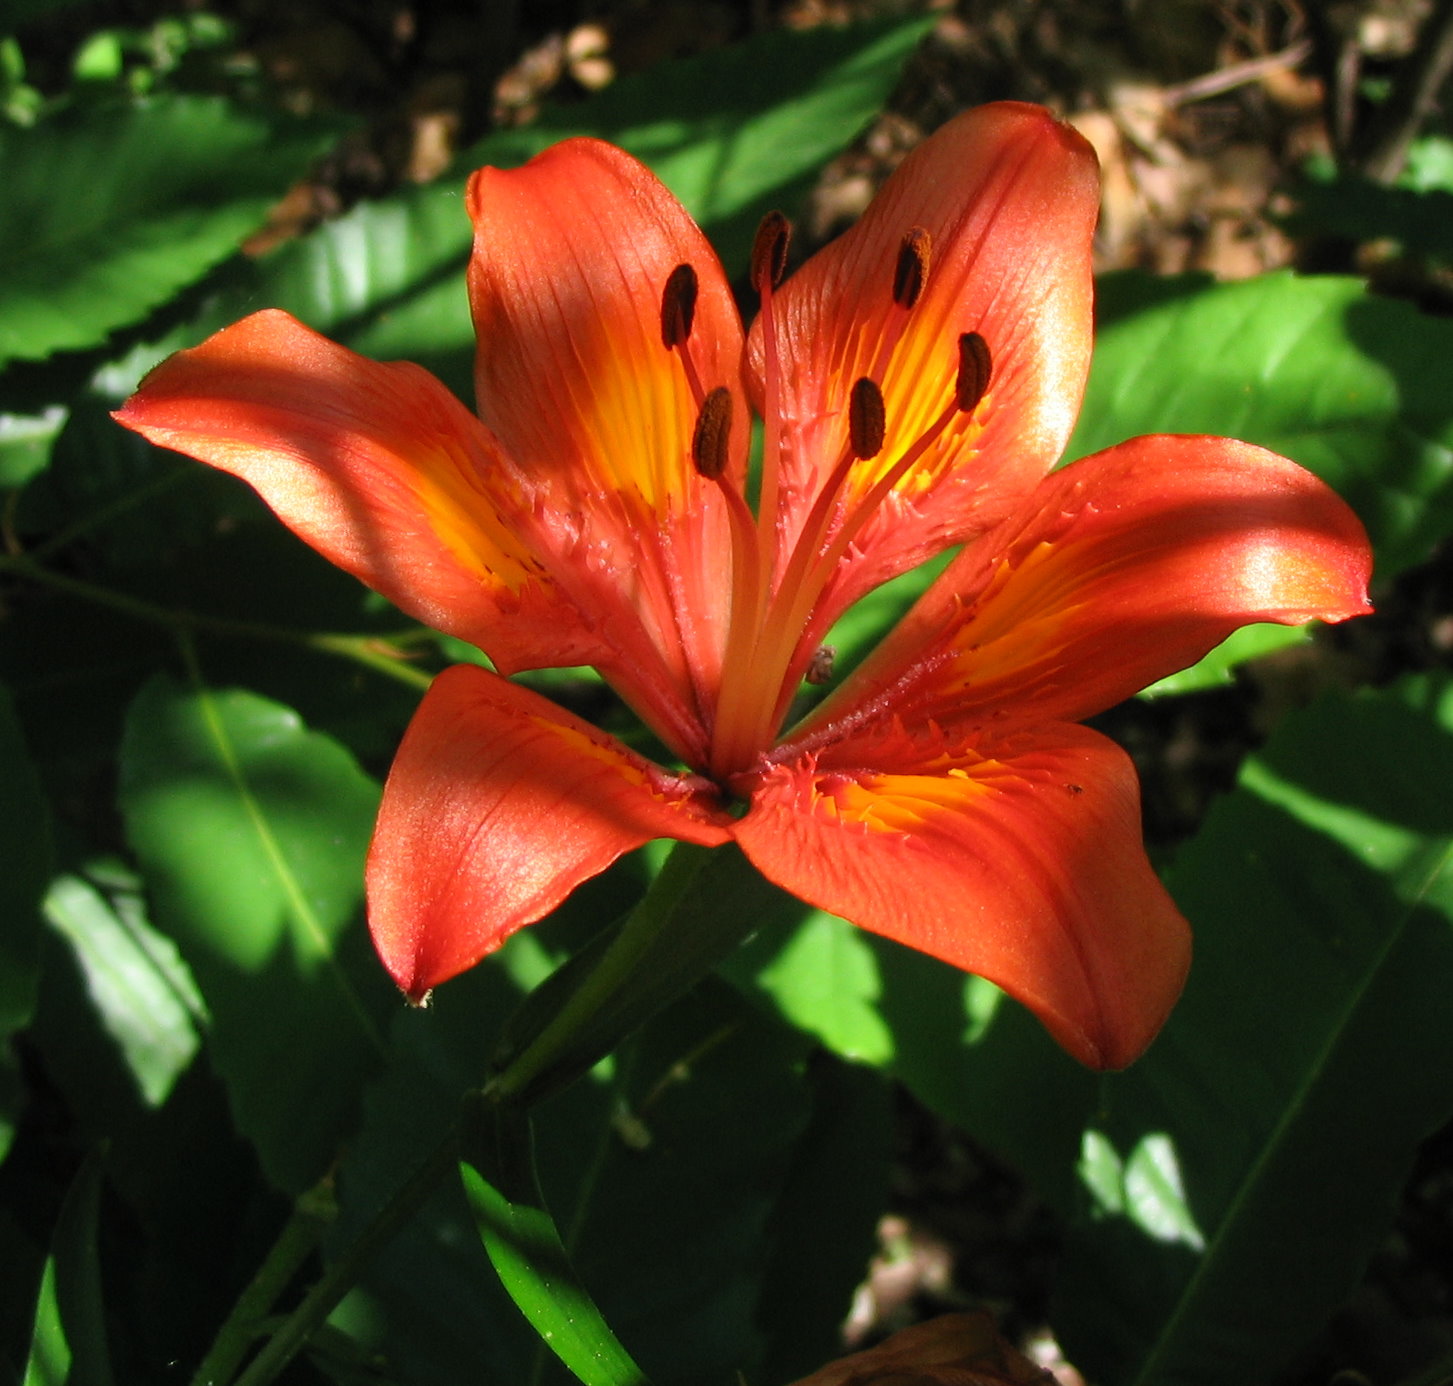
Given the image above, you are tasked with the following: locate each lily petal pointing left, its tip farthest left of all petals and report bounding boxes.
[115,311,607,671]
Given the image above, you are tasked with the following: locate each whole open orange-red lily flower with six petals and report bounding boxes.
[118,105,1370,1066]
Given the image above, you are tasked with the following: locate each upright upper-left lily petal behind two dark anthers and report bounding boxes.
[468,139,750,735]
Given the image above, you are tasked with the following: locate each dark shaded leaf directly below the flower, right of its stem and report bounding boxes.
[539,978,825,1386]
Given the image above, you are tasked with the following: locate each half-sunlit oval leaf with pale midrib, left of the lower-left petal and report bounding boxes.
[121,678,391,1191]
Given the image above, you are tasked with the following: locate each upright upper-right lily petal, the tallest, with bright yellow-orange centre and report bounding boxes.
[750,103,1100,610]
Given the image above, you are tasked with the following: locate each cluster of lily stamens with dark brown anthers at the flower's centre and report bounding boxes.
[661,212,992,785]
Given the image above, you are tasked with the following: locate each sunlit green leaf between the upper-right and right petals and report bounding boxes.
[1069,275,1453,578]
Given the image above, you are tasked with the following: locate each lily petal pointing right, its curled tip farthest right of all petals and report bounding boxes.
[793,436,1372,744]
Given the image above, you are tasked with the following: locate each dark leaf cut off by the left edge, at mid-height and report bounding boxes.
[0,674,51,1040]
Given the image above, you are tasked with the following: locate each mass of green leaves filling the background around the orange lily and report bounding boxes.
[0,0,1453,1386]
